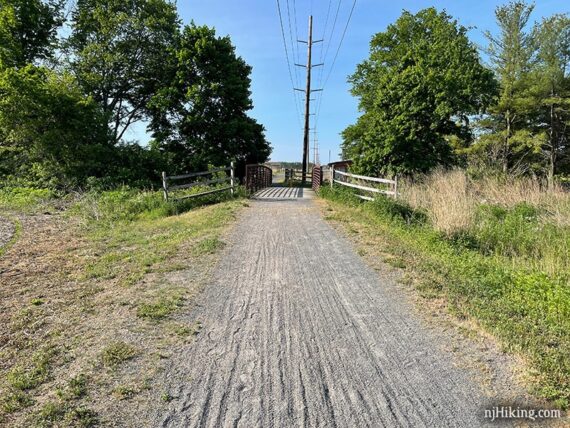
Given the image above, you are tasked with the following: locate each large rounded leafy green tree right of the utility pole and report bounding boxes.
[342,8,496,174]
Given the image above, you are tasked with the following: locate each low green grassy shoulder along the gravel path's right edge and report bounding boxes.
[320,187,570,408]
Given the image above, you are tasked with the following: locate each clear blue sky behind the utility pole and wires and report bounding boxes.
[132,0,570,162]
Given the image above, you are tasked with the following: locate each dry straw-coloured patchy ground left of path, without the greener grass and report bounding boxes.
[0,208,240,427]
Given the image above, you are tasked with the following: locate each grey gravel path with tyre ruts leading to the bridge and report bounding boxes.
[151,195,485,428]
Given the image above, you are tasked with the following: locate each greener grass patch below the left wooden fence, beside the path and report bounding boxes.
[75,187,240,286]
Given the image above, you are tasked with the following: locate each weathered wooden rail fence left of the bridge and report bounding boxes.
[162,162,236,202]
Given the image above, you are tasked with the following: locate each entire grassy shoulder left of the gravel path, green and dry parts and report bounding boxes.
[0,189,245,427]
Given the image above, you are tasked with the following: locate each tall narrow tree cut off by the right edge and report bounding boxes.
[533,15,570,183]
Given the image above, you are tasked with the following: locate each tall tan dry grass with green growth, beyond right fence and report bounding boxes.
[401,170,570,275]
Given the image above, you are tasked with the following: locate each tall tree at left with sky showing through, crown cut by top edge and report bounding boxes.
[68,0,179,143]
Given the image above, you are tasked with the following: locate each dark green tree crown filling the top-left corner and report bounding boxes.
[0,0,64,68]
